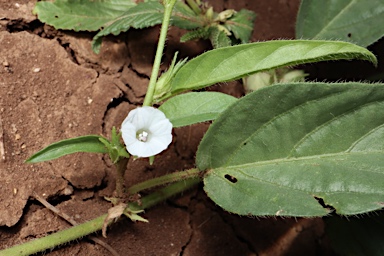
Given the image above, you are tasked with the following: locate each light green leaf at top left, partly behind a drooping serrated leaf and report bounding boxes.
[33,0,136,31]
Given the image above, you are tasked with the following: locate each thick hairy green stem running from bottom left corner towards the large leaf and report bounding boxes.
[0,178,201,256]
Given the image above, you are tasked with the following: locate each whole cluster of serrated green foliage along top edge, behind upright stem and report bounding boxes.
[34,0,256,53]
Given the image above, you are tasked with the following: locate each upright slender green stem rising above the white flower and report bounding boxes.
[143,0,176,106]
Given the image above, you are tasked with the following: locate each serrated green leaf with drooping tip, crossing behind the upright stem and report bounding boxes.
[92,1,202,53]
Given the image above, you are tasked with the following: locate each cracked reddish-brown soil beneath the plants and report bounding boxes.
[0,0,354,256]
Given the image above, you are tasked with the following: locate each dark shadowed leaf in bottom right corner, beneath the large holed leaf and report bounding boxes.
[325,213,384,256]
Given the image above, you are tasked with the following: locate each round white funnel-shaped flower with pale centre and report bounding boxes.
[121,107,172,157]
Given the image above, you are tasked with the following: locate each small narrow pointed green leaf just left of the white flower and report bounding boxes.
[26,135,108,163]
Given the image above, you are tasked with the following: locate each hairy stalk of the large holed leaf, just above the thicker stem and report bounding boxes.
[127,169,201,195]
